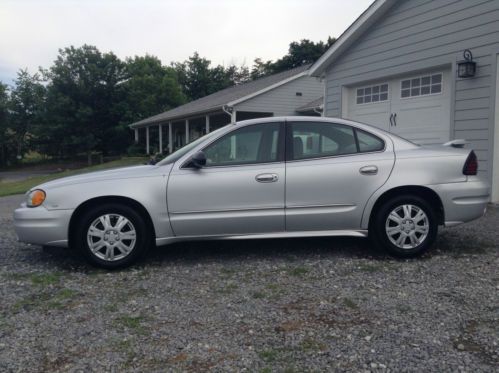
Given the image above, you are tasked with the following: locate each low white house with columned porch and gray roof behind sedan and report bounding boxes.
[130,65,324,154]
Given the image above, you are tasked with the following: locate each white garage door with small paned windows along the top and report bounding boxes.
[344,71,451,144]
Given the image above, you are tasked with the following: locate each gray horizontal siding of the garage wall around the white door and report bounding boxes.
[324,0,499,177]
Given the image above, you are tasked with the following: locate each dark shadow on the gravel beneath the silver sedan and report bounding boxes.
[41,237,391,271]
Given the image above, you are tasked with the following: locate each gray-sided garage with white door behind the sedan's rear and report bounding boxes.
[310,0,499,202]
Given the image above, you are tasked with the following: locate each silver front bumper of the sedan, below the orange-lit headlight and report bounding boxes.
[14,204,73,247]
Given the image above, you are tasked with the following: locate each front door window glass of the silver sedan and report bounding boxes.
[203,123,280,167]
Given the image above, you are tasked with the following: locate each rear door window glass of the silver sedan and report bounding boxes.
[289,122,358,160]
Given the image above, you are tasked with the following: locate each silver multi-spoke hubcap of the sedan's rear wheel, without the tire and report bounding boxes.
[385,205,430,249]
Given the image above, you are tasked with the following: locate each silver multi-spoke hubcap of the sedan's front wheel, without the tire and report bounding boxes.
[87,214,137,262]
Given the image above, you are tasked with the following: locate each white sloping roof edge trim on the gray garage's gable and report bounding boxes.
[309,0,397,77]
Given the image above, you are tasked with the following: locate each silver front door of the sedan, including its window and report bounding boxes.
[167,122,285,236]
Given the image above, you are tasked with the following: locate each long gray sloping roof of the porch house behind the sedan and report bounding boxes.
[130,64,310,128]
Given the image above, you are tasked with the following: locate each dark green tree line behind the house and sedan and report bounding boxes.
[0,38,335,166]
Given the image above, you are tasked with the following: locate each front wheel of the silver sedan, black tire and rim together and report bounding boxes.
[74,203,151,269]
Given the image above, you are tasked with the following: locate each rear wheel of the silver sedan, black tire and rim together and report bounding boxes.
[369,195,438,258]
